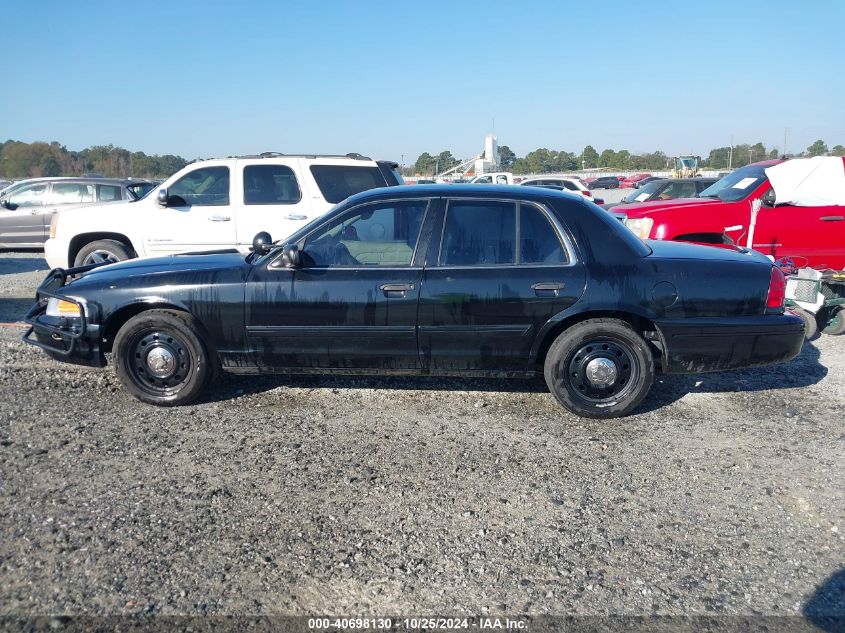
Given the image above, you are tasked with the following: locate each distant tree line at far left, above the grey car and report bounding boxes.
[0,140,190,179]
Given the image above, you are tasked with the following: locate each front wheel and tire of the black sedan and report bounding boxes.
[113,310,217,407]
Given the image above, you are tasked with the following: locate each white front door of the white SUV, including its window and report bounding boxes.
[139,165,236,255]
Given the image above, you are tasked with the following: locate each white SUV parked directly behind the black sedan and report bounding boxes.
[44,152,403,268]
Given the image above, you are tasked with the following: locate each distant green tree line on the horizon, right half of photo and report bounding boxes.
[406,140,845,175]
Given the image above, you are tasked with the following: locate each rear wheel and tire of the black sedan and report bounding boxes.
[543,319,654,419]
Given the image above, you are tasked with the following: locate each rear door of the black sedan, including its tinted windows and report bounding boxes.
[419,199,584,373]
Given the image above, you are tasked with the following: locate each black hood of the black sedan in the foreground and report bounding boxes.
[68,250,249,288]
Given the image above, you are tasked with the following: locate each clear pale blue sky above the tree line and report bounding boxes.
[0,0,845,163]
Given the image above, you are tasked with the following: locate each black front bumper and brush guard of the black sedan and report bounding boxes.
[23,264,106,367]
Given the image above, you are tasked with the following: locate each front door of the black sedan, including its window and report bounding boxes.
[246,200,428,372]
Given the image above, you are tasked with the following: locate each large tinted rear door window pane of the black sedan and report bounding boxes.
[439,200,516,266]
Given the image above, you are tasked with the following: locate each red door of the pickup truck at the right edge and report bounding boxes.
[753,188,845,269]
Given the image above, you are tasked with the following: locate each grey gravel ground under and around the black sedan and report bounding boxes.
[0,249,845,615]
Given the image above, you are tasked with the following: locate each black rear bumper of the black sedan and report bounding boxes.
[656,312,804,374]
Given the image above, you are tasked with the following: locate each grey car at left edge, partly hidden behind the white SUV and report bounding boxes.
[0,177,154,248]
